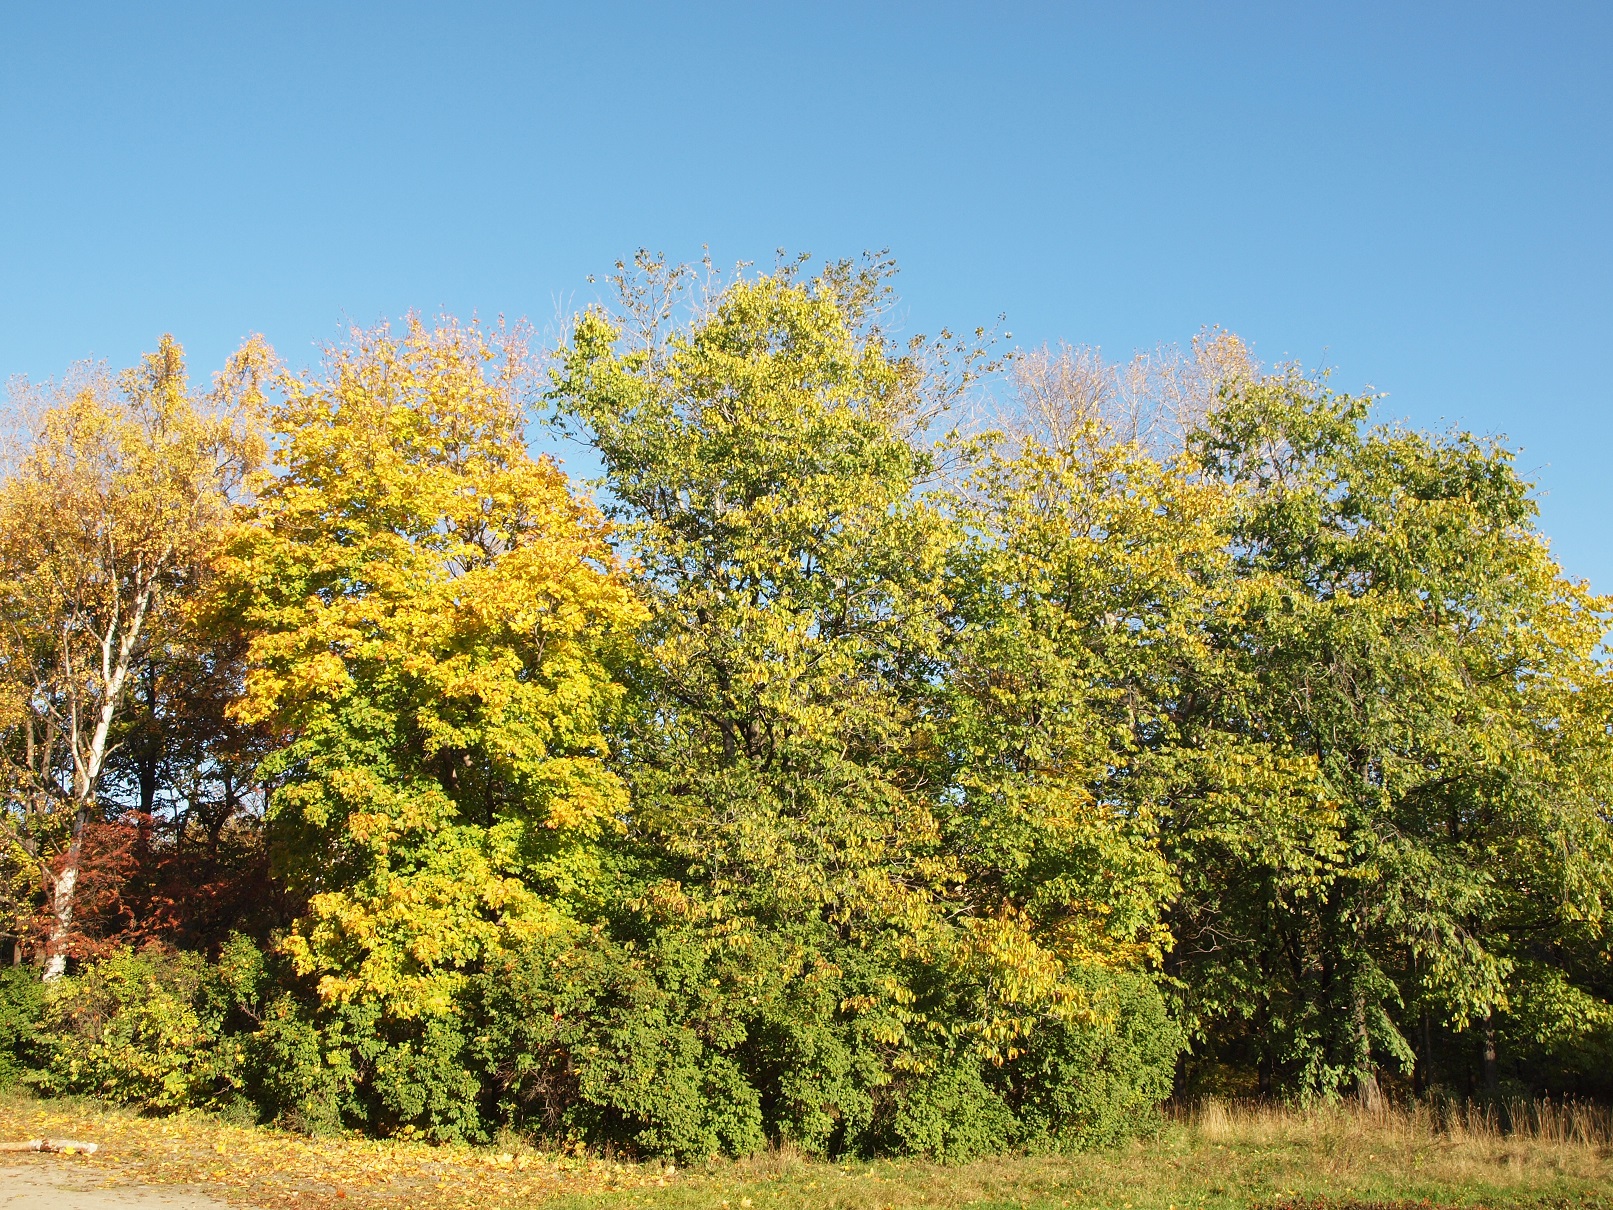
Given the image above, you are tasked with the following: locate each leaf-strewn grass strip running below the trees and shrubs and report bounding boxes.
[0,1095,1613,1210]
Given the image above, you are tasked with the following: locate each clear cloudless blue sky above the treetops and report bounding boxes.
[0,0,1613,590]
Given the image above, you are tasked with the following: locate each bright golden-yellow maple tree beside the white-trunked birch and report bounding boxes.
[219,318,639,1020]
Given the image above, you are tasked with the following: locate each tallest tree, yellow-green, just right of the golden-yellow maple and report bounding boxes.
[555,253,961,1149]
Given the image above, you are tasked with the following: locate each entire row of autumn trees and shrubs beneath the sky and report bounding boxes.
[0,255,1613,1158]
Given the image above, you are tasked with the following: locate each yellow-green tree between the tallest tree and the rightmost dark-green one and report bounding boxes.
[945,390,1309,1136]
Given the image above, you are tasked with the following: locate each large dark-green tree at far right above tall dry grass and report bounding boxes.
[1166,371,1610,1102]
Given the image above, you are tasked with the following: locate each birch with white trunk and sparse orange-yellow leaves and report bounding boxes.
[0,336,271,979]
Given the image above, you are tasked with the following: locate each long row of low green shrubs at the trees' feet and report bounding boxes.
[0,934,1181,1162]
